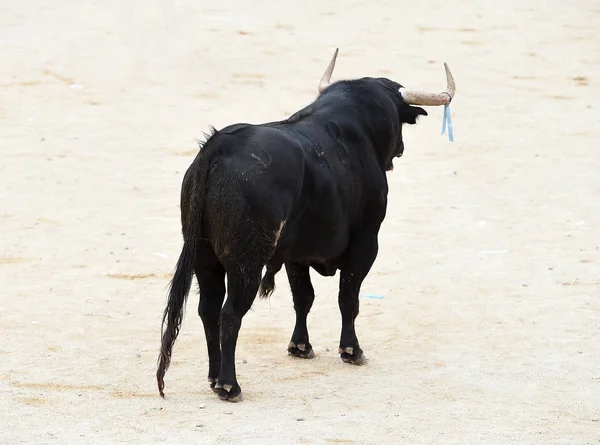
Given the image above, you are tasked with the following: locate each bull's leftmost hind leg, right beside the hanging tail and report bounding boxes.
[195,252,225,390]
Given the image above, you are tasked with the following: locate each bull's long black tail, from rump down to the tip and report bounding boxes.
[156,138,216,398]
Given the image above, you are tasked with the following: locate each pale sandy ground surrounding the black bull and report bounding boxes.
[0,0,600,444]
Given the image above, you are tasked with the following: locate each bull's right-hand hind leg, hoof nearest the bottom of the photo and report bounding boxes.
[215,267,262,402]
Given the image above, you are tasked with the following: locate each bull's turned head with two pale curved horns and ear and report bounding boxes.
[319,49,456,170]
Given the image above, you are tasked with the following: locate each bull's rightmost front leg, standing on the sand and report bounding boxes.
[338,233,379,365]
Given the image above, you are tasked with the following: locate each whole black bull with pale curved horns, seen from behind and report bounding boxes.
[156,52,454,401]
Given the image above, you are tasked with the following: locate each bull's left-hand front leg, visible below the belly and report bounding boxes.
[285,263,315,358]
